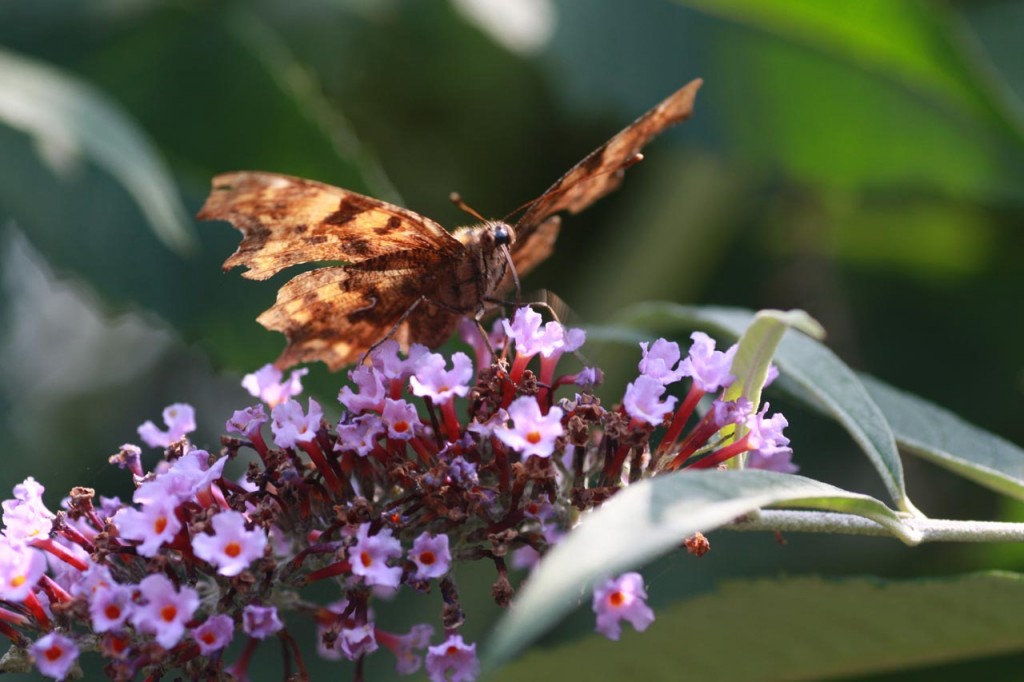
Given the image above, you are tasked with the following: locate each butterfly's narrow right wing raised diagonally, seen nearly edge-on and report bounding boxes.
[513,78,703,245]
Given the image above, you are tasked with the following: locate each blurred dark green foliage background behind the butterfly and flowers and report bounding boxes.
[0,0,1024,679]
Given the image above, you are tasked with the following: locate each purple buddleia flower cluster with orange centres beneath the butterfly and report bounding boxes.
[0,308,792,681]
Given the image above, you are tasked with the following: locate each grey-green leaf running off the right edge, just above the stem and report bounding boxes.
[860,375,1024,500]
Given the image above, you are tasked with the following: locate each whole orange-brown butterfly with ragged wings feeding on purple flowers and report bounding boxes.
[198,79,701,371]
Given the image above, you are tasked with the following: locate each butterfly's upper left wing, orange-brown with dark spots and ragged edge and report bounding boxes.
[199,171,464,280]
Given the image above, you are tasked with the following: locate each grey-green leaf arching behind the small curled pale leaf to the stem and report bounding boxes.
[606,303,915,512]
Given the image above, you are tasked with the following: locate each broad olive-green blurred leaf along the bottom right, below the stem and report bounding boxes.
[495,573,1024,682]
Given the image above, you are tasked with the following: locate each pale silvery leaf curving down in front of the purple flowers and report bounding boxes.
[488,470,920,662]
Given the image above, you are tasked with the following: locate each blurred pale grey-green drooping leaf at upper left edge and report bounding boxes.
[0,49,196,252]
